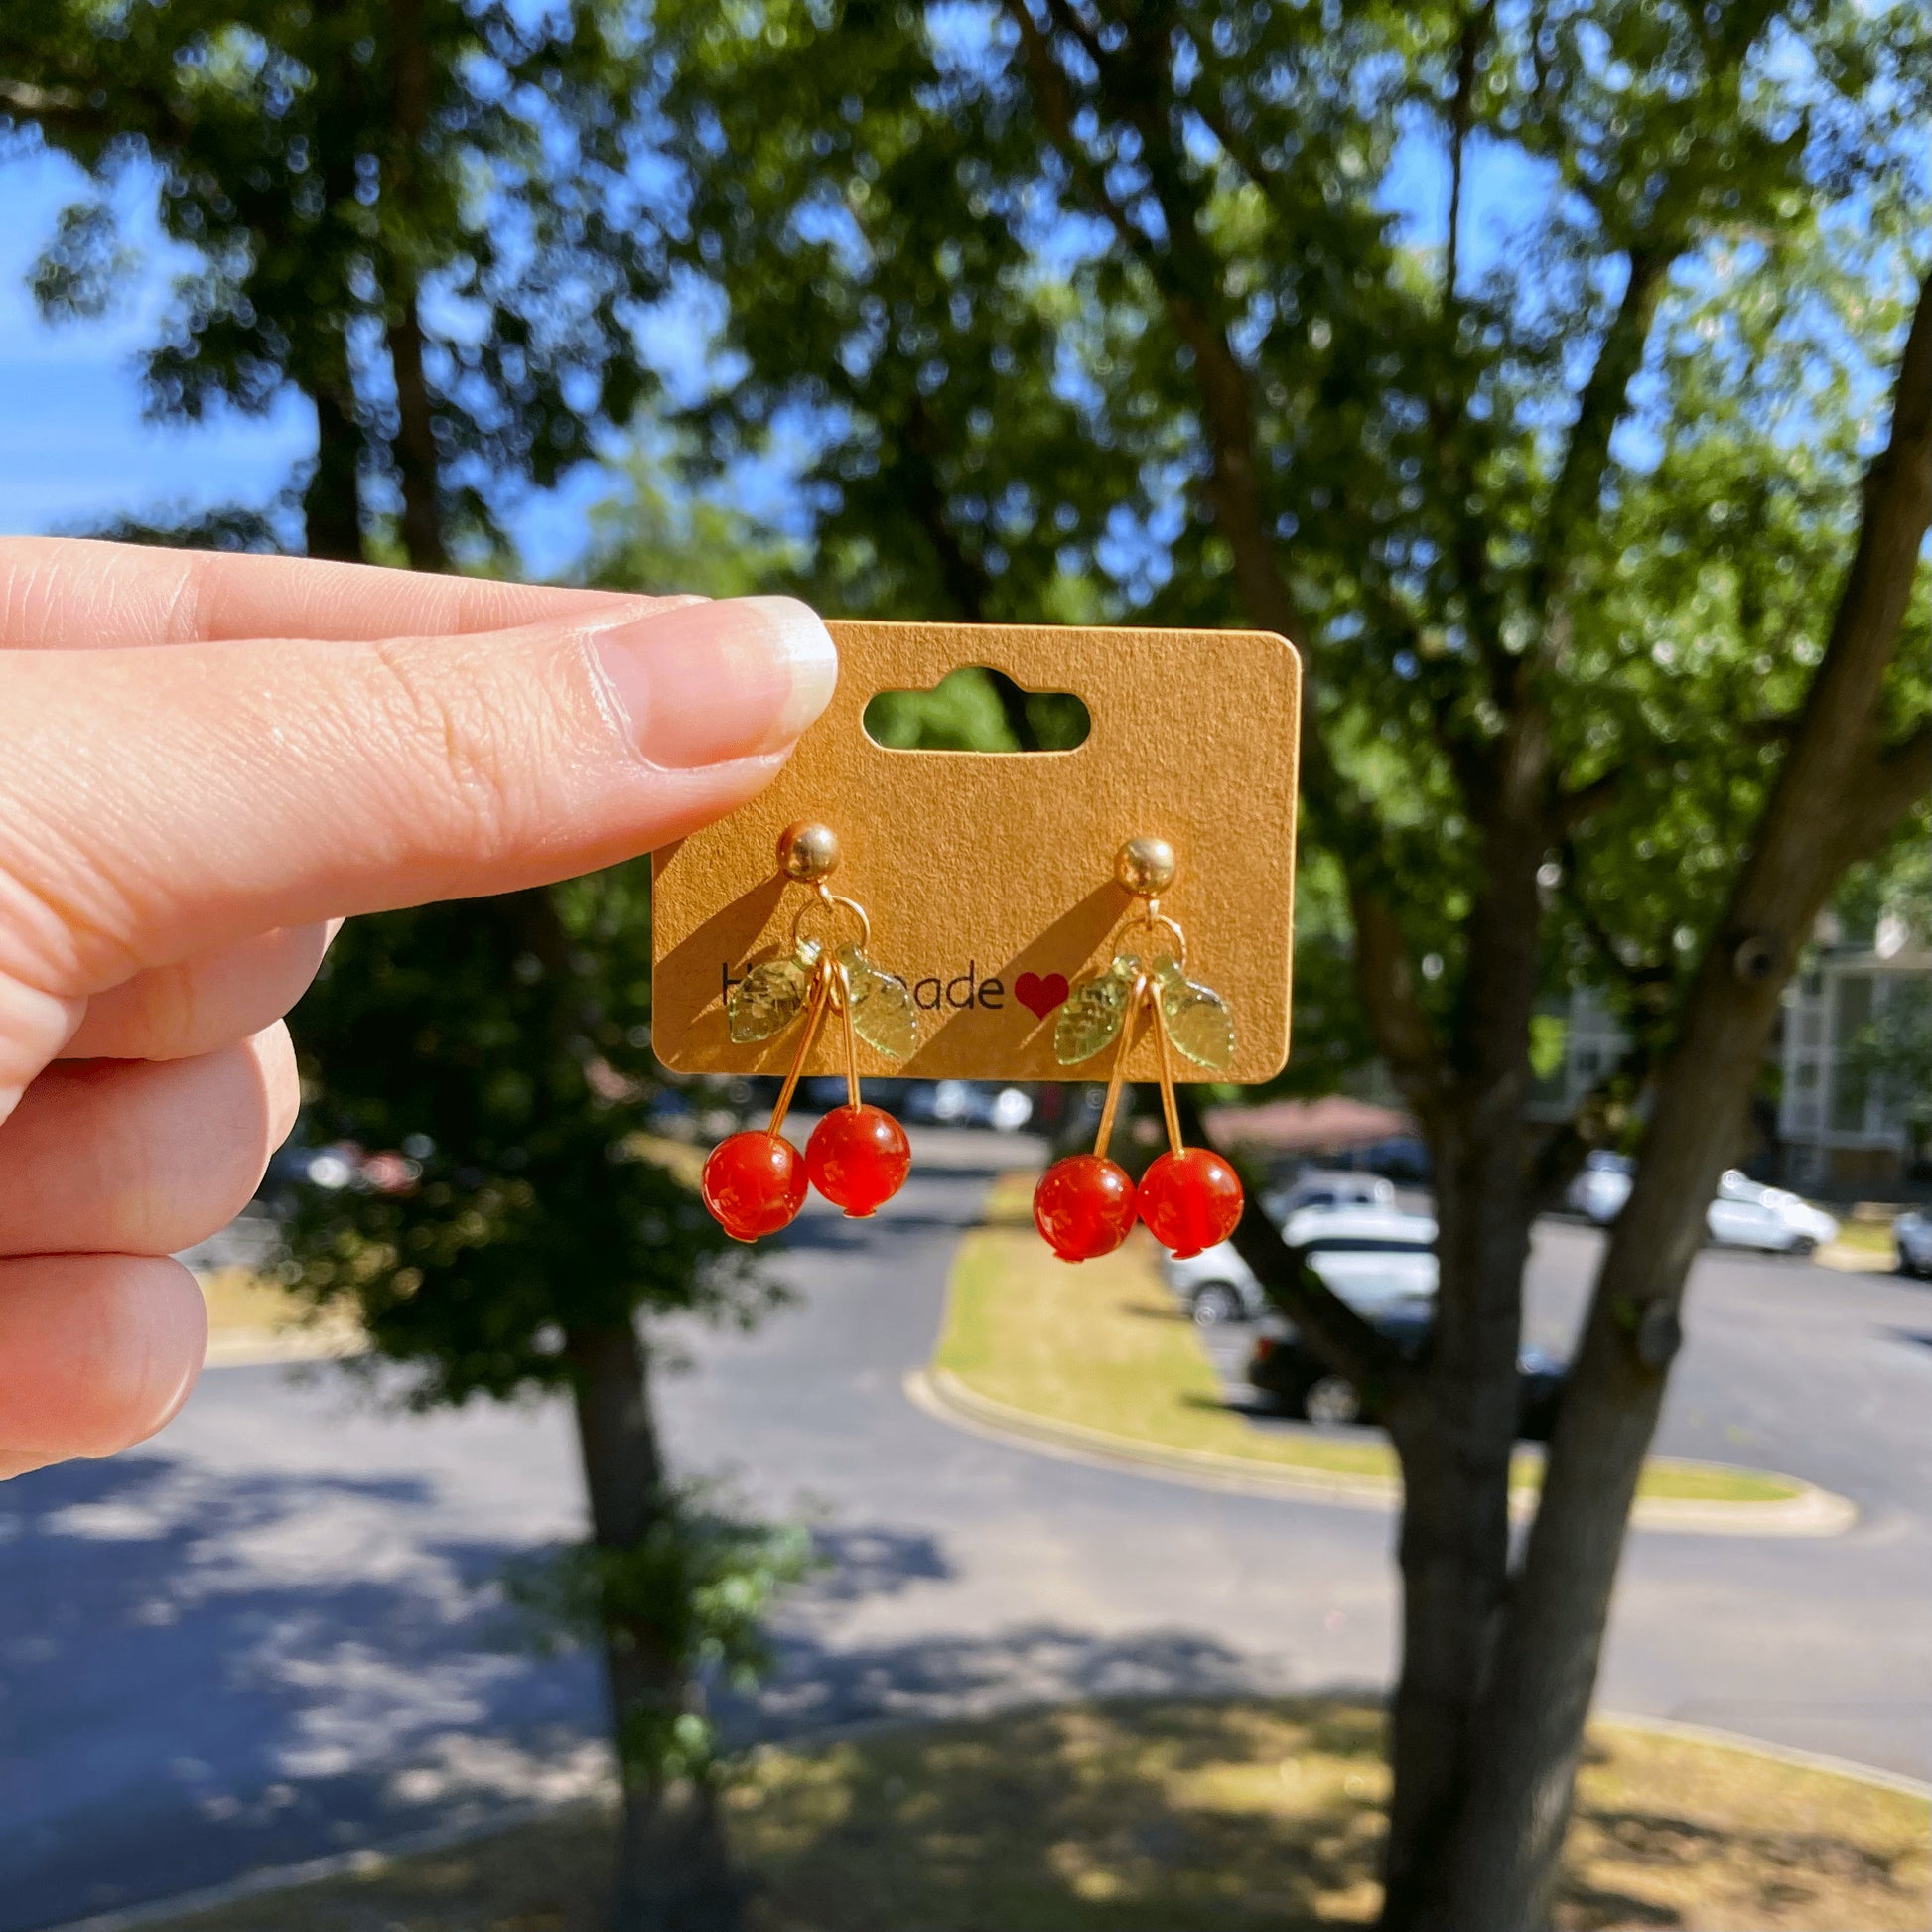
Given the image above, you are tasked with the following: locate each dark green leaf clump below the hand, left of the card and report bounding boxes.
[290,877,774,1407]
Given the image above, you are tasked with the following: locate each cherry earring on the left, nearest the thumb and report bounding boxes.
[701,821,919,1240]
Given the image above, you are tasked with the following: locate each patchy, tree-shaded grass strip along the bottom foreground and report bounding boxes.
[146,1699,1928,1932]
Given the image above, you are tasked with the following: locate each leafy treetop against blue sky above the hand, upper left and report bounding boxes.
[0,0,662,570]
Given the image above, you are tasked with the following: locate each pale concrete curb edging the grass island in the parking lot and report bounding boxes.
[902,1368,1859,1536]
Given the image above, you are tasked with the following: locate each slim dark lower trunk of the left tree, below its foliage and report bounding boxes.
[566,1325,744,1932]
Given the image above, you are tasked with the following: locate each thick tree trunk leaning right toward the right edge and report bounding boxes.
[1420,268,1932,1932]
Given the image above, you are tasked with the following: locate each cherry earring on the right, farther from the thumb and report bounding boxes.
[1034,839,1242,1262]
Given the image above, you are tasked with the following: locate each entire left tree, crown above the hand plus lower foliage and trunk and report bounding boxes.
[0,11,798,1932]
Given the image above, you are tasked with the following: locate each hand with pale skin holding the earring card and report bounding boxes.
[0,539,837,1476]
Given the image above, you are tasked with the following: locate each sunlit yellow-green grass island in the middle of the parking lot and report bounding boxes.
[933,1174,1799,1503]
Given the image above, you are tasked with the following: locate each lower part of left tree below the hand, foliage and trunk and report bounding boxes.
[288,877,804,1932]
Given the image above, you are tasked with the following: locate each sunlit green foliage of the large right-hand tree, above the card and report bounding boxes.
[641,0,1932,1105]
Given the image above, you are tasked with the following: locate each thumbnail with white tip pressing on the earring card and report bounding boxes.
[590,597,839,770]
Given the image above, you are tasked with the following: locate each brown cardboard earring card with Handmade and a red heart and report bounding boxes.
[651,622,1301,1082]
